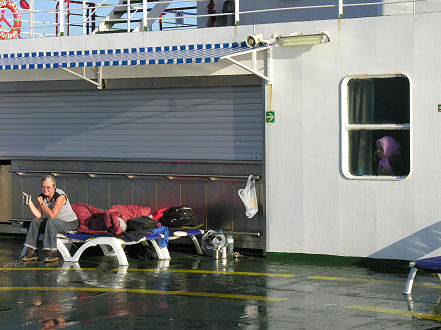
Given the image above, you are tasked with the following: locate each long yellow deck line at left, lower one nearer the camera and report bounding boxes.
[0,286,288,302]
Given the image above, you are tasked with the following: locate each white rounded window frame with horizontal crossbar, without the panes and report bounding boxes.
[340,73,413,181]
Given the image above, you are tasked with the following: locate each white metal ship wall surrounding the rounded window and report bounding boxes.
[262,13,441,260]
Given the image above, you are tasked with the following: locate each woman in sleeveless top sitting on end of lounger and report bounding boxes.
[21,175,79,262]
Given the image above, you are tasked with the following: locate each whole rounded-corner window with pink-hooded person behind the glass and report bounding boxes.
[341,75,410,180]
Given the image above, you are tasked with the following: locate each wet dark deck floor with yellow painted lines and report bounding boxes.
[0,236,441,329]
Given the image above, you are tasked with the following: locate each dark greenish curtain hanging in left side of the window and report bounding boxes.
[348,79,374,175]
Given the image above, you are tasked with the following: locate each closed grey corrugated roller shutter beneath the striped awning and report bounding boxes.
[0,86,263,160]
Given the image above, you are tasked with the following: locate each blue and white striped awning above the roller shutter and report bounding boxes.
[0,42,262,70]
